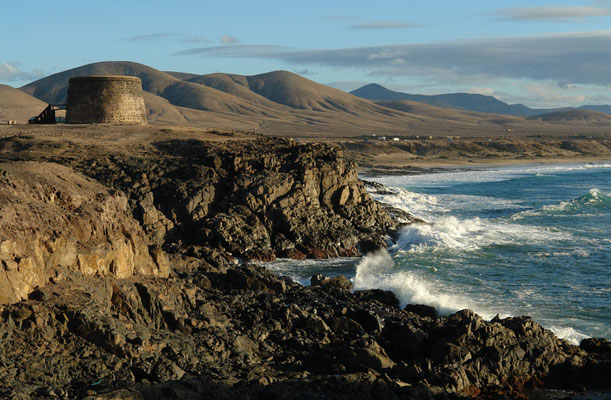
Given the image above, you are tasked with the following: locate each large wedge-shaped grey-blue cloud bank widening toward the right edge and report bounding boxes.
[254,31,611,85]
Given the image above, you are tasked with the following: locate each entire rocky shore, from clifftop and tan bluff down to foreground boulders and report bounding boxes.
[0,128,611,400]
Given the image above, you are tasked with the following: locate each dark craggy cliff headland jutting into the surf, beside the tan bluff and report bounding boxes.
[70,139,399,260]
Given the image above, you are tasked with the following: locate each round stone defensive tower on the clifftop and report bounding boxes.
[66,76,146,125]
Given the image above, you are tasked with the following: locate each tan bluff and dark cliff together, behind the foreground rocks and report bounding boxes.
[0,136,399,303]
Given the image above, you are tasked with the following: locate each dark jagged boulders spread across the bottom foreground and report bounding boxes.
[0,260,611,399]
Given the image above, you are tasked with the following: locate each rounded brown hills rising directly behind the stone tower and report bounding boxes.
[21,61,412,133]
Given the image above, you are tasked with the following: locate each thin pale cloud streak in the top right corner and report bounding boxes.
[495,6,611,22]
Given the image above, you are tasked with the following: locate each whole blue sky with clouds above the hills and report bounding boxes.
[0,0,611,108]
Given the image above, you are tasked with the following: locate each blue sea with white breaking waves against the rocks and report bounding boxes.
[268,163,611,344]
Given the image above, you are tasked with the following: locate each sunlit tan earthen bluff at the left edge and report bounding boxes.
[0,162,169,303]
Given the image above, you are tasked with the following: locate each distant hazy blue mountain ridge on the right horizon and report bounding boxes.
[350,83,611,117]
